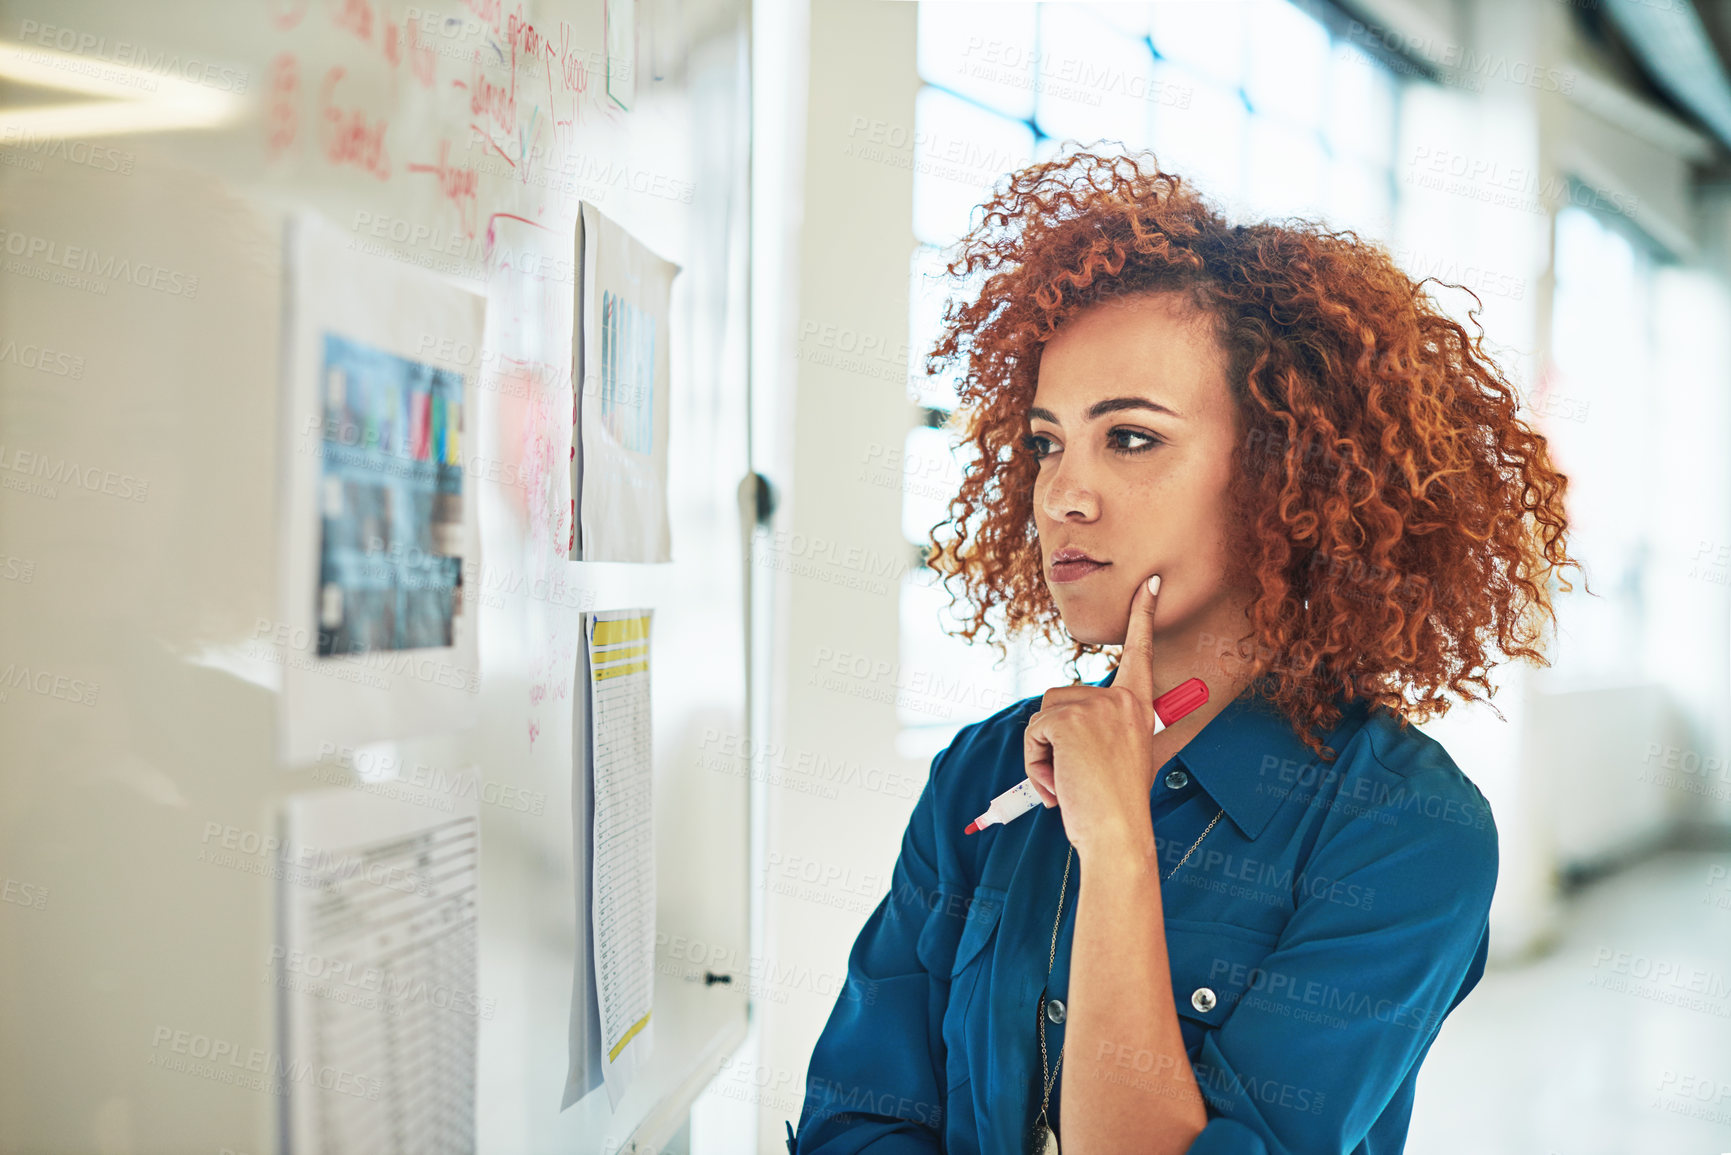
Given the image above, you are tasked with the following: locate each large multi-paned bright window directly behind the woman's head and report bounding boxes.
[898,0,1400,758]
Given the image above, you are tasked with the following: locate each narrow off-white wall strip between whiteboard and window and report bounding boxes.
[756,0,928,1152]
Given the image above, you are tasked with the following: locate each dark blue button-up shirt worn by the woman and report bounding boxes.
[788,675,1497,1155]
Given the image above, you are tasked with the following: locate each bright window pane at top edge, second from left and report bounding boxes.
[1035,3,1155,149]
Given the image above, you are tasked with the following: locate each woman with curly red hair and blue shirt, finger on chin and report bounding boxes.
[788,152,1573,1155]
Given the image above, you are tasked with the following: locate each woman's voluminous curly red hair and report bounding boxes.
[926,151,1591,760]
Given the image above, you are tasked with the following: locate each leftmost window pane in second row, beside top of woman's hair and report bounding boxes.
[914,87,1033,244]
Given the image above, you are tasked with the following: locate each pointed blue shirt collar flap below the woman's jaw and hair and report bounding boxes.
[1096,668,1367,838]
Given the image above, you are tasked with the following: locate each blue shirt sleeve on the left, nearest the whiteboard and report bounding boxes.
[788,743,962,1155]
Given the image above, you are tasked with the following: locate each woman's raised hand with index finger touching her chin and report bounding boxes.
[1021,575,1160,855]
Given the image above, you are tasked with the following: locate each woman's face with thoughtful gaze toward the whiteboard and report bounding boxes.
[1028,293,1246,661]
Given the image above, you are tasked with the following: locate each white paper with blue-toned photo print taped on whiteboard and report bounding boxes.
[273,213,485,764]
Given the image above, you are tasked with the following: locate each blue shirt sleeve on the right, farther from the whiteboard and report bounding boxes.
[1187,767,1497,1155]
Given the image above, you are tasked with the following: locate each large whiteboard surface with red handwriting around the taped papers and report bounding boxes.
[0,0,753,1153]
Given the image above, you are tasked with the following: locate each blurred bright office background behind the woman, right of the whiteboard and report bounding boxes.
[692,0,1731,1155]
